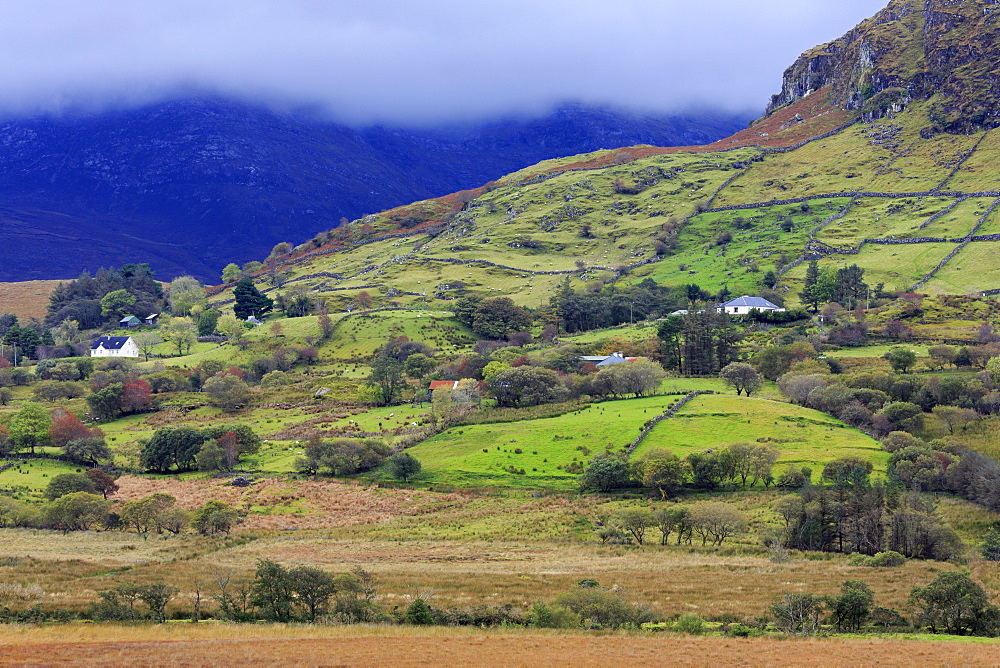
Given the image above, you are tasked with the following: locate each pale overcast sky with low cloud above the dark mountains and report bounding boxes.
[0,0,887,125]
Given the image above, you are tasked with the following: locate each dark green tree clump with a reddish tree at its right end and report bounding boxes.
[140,424,261,473]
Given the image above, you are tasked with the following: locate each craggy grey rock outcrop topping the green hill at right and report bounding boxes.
[768,0,1000,134]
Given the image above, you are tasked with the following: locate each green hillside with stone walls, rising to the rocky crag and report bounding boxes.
[207,0,1000,316]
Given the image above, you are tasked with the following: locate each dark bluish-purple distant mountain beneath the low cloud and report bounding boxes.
[0,99,746,281]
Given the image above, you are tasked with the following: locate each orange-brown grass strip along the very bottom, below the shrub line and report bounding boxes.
[0,623,1000,666]
